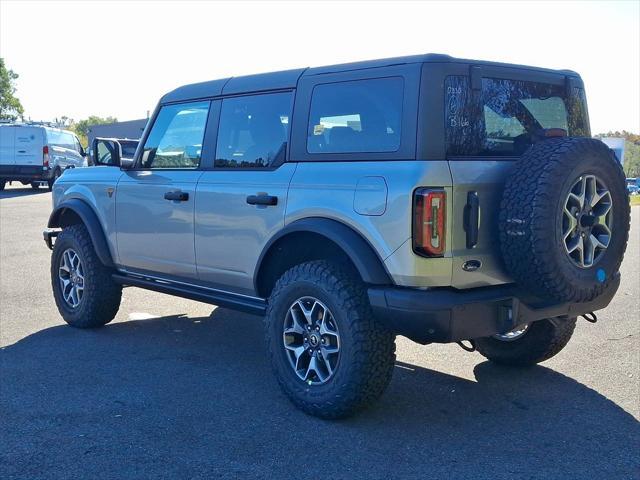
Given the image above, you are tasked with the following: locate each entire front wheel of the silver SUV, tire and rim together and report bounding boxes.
[51,224,122,328]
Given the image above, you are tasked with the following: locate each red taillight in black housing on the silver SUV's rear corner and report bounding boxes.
[413,188,446,257]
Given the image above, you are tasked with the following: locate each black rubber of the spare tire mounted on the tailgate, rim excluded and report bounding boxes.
[499,138,630,302]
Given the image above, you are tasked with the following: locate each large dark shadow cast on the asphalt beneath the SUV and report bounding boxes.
[0,308,640,479]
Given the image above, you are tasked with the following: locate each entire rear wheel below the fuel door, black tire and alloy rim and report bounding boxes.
[265,261,395,418]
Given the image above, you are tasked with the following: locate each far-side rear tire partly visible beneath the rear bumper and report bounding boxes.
[475,317,576,367]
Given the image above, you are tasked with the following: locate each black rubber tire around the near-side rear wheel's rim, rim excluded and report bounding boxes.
[265,261,395,419]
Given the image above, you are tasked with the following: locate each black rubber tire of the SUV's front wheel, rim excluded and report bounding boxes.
[51,224,122,328]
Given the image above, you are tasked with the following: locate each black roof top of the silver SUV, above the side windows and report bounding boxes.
[160,53,579,103]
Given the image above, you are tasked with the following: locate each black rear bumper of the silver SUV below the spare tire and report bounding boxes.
[369,275,620,344]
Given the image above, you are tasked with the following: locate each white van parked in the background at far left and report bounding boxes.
[0,123,85,190]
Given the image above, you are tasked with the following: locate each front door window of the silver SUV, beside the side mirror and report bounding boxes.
[142,102,210,168]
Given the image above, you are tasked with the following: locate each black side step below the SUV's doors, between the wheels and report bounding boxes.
[112,273,267,315]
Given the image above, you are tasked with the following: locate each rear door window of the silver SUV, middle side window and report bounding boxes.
[214,92,292,168]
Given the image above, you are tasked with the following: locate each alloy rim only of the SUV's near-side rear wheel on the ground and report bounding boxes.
[283,297,340,385]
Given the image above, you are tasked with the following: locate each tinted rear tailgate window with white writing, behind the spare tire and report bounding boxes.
[445,76,589,157]
